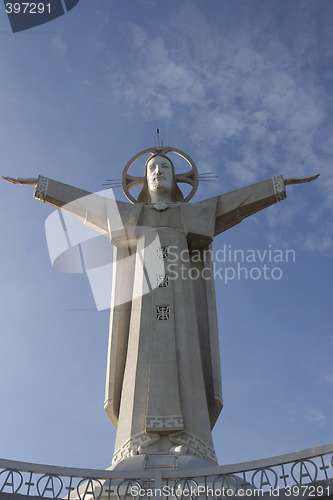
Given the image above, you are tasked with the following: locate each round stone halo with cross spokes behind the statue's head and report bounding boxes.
[121,146,199,203]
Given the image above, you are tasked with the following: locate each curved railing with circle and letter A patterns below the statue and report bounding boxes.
[0,443,333,500]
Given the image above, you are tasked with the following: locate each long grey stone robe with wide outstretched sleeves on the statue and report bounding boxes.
[35,177,286,463]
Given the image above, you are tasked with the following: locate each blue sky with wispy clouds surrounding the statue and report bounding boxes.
[0,0,333,468]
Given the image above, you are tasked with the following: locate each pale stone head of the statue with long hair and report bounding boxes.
[138,154,184,203]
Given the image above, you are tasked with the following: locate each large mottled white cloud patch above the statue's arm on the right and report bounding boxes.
[108,19,325,162]
